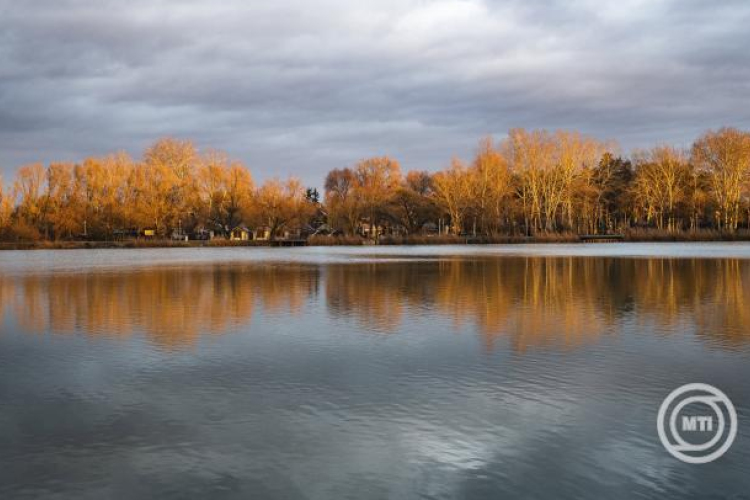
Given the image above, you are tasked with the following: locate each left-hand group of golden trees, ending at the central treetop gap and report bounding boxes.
[0,139,315,240]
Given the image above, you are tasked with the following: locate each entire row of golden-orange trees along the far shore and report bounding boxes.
[0,128,750,241]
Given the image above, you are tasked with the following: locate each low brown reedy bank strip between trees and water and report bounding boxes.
[0,230,750,250]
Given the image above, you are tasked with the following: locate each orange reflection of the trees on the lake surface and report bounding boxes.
[0,257,750,352]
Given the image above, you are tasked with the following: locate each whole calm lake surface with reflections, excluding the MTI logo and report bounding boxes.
[0,244,750,500]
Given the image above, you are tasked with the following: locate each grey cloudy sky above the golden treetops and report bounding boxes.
[0,0,750,186]
